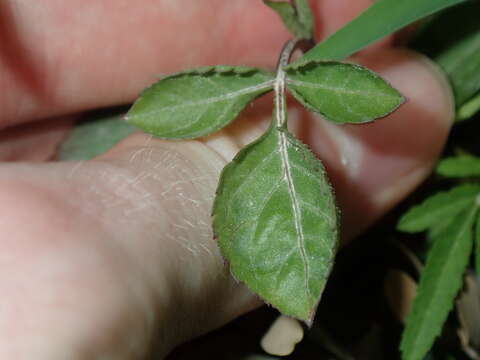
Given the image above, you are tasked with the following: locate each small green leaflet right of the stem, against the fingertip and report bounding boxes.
[287,61,404,124]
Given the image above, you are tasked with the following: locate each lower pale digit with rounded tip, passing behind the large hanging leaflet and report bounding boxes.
[0,50,453,354]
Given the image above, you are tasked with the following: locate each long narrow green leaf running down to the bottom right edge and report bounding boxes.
[400,206,477,360]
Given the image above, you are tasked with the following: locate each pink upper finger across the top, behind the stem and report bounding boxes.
[0,0,382,128]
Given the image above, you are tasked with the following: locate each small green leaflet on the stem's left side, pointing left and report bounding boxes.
[126,66,273,139]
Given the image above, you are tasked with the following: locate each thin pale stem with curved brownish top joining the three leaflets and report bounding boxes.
[273,39,312,127]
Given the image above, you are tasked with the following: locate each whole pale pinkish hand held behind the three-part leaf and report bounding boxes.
[0,0,453,360]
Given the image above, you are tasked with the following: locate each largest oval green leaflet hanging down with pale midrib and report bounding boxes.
[213,126,337,323]
